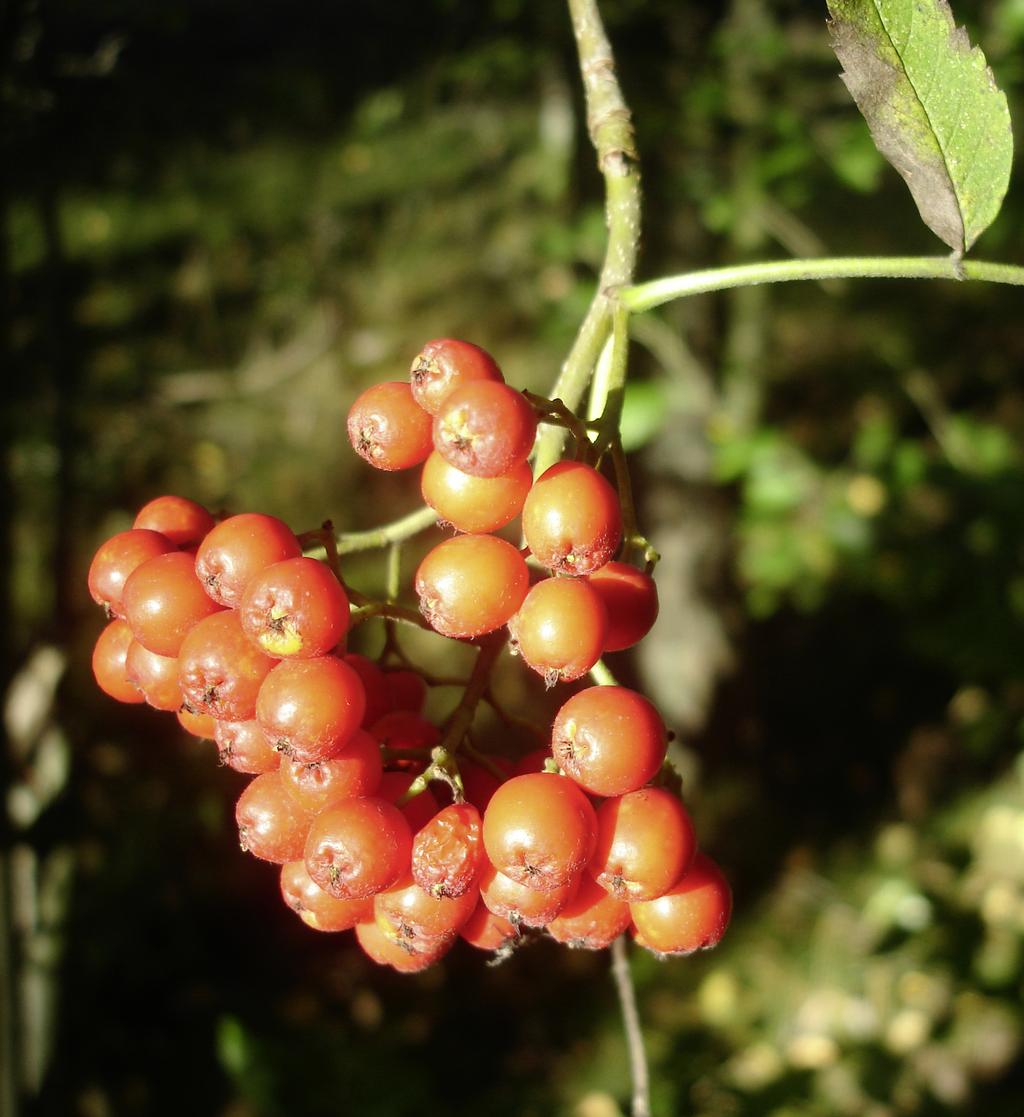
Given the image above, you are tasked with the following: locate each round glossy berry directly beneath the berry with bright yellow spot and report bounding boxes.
[256,656,366,764]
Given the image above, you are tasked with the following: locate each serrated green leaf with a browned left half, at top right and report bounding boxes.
[829,0,1013,256]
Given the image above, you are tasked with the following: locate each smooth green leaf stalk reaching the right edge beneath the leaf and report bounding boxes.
[618,256,1024,314]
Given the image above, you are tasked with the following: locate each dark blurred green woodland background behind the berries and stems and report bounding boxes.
[6,0,1024,1117]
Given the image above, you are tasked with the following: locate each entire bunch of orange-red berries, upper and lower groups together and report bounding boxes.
[88,340,730,972]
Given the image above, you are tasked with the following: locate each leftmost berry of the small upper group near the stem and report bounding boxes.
[348,380,433,472]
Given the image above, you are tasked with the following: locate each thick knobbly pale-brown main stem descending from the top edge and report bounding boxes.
[535,0,640,476]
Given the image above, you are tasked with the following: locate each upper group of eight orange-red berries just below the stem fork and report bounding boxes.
[348,338,658,685]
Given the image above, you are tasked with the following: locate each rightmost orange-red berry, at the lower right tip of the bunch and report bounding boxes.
[630,852,733,954]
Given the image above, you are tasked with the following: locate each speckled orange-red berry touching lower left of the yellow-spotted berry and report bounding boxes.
[178,610,277,722]
